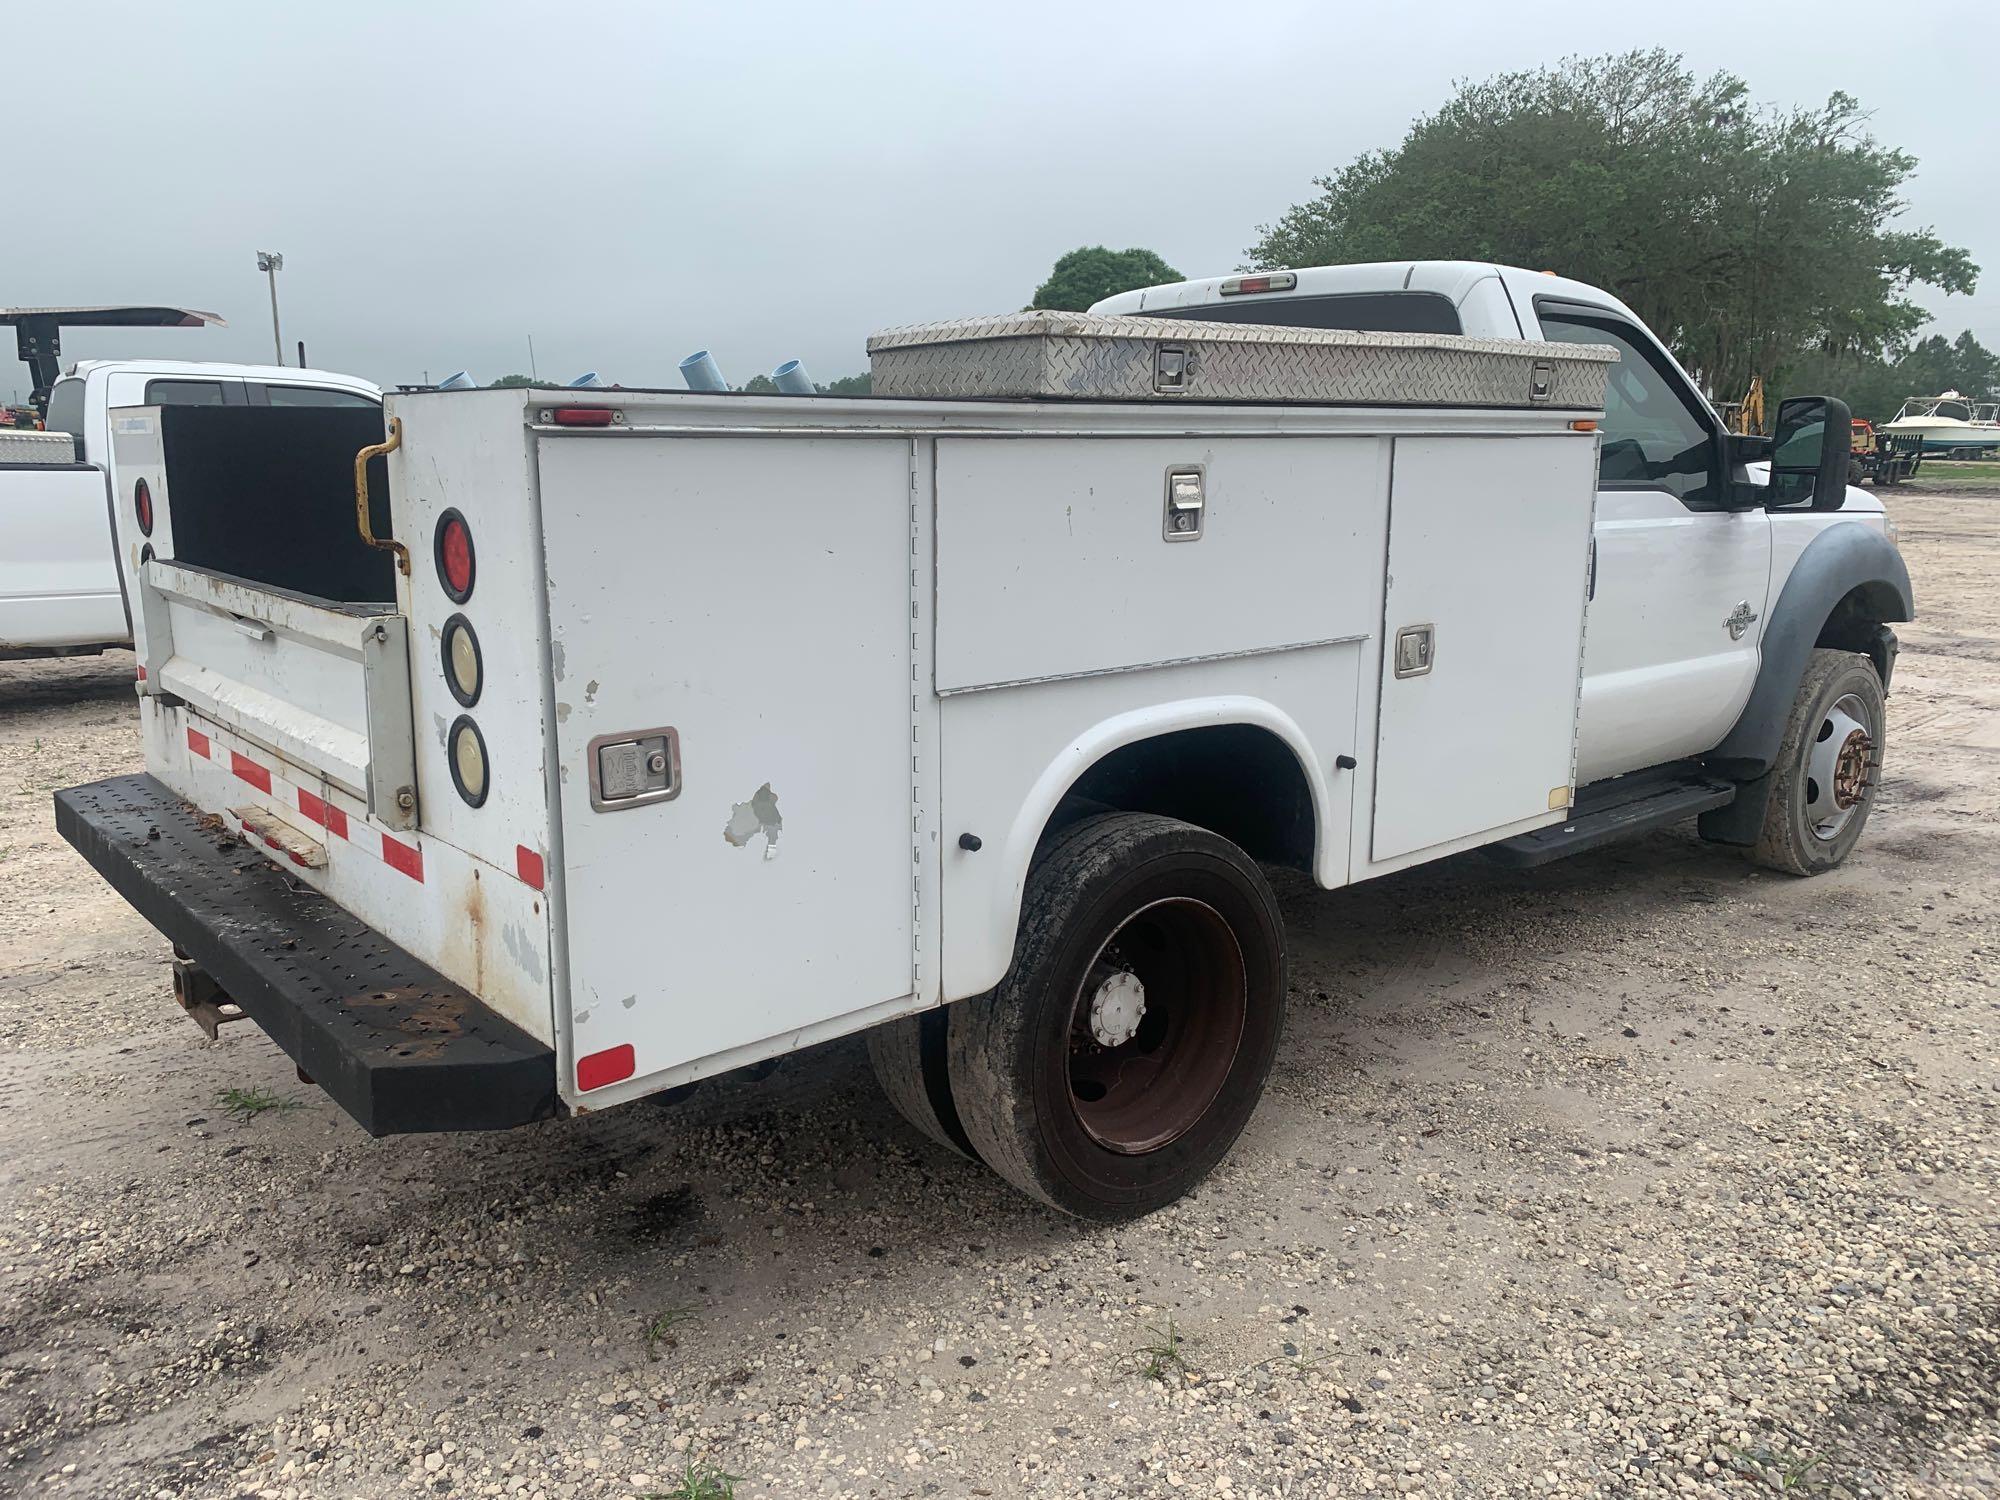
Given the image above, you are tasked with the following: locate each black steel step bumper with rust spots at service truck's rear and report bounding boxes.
[56,776,560,1136]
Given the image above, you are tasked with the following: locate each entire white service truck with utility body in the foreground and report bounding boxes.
[56,266,1910,1218]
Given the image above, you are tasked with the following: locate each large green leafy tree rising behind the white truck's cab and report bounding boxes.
[1248,50,1978,406]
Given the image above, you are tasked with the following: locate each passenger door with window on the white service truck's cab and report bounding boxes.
[1536,312,1770,784]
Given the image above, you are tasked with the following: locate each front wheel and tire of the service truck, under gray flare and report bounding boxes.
[1750,648,1886,876]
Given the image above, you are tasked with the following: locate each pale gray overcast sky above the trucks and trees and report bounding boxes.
[0,0,2000,396]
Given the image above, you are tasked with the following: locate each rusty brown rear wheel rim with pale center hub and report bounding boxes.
[1068,896,1250,1156]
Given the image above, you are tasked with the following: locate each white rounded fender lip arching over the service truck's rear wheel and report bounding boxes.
[944,694,1346,1000]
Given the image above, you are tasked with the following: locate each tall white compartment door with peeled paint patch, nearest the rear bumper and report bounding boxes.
[548,434,928,1102]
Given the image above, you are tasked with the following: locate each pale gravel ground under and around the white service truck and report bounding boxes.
[0,494,2000,1500]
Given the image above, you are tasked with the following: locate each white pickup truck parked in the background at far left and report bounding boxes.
[0,360,382,658]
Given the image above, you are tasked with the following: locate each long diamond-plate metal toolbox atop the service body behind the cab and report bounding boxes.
[868,312,1618,412]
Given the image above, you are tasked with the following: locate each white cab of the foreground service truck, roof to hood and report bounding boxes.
[1092,260,1908,816]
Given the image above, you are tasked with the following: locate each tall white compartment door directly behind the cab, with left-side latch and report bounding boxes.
[1370,434,1596,862]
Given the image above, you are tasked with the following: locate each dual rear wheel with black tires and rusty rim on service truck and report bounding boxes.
[946,812,1286,1220]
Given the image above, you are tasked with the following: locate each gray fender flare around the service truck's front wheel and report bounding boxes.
[1702,520,1916,844]
